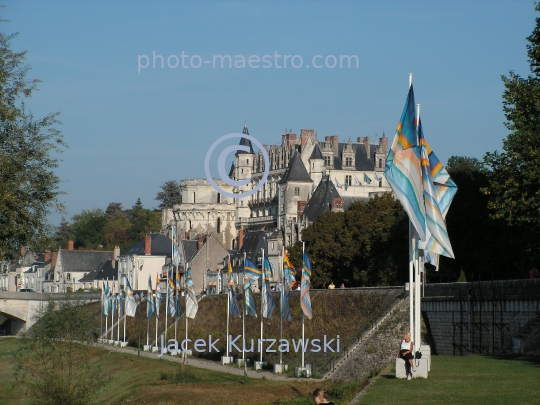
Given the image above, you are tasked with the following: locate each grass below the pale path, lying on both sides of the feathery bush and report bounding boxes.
[0,338,319,405]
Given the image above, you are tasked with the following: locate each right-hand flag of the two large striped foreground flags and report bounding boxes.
[418,121,457,258]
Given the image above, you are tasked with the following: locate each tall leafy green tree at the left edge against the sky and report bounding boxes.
[0,25,66,257]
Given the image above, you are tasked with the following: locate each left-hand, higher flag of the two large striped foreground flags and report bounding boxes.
[384,85,426,240]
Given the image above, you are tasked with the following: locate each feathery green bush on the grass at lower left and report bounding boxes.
[14,295,110,405]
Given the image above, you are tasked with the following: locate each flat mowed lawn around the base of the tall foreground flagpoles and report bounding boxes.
[360,356,540,405]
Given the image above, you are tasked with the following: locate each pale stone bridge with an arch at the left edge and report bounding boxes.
[0,292,101,335]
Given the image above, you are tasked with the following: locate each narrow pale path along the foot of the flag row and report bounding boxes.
[98,344,322,381]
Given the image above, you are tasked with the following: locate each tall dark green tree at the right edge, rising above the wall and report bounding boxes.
[483,4,540,258]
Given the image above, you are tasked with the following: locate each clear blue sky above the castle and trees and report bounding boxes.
[4,0,536,224]
